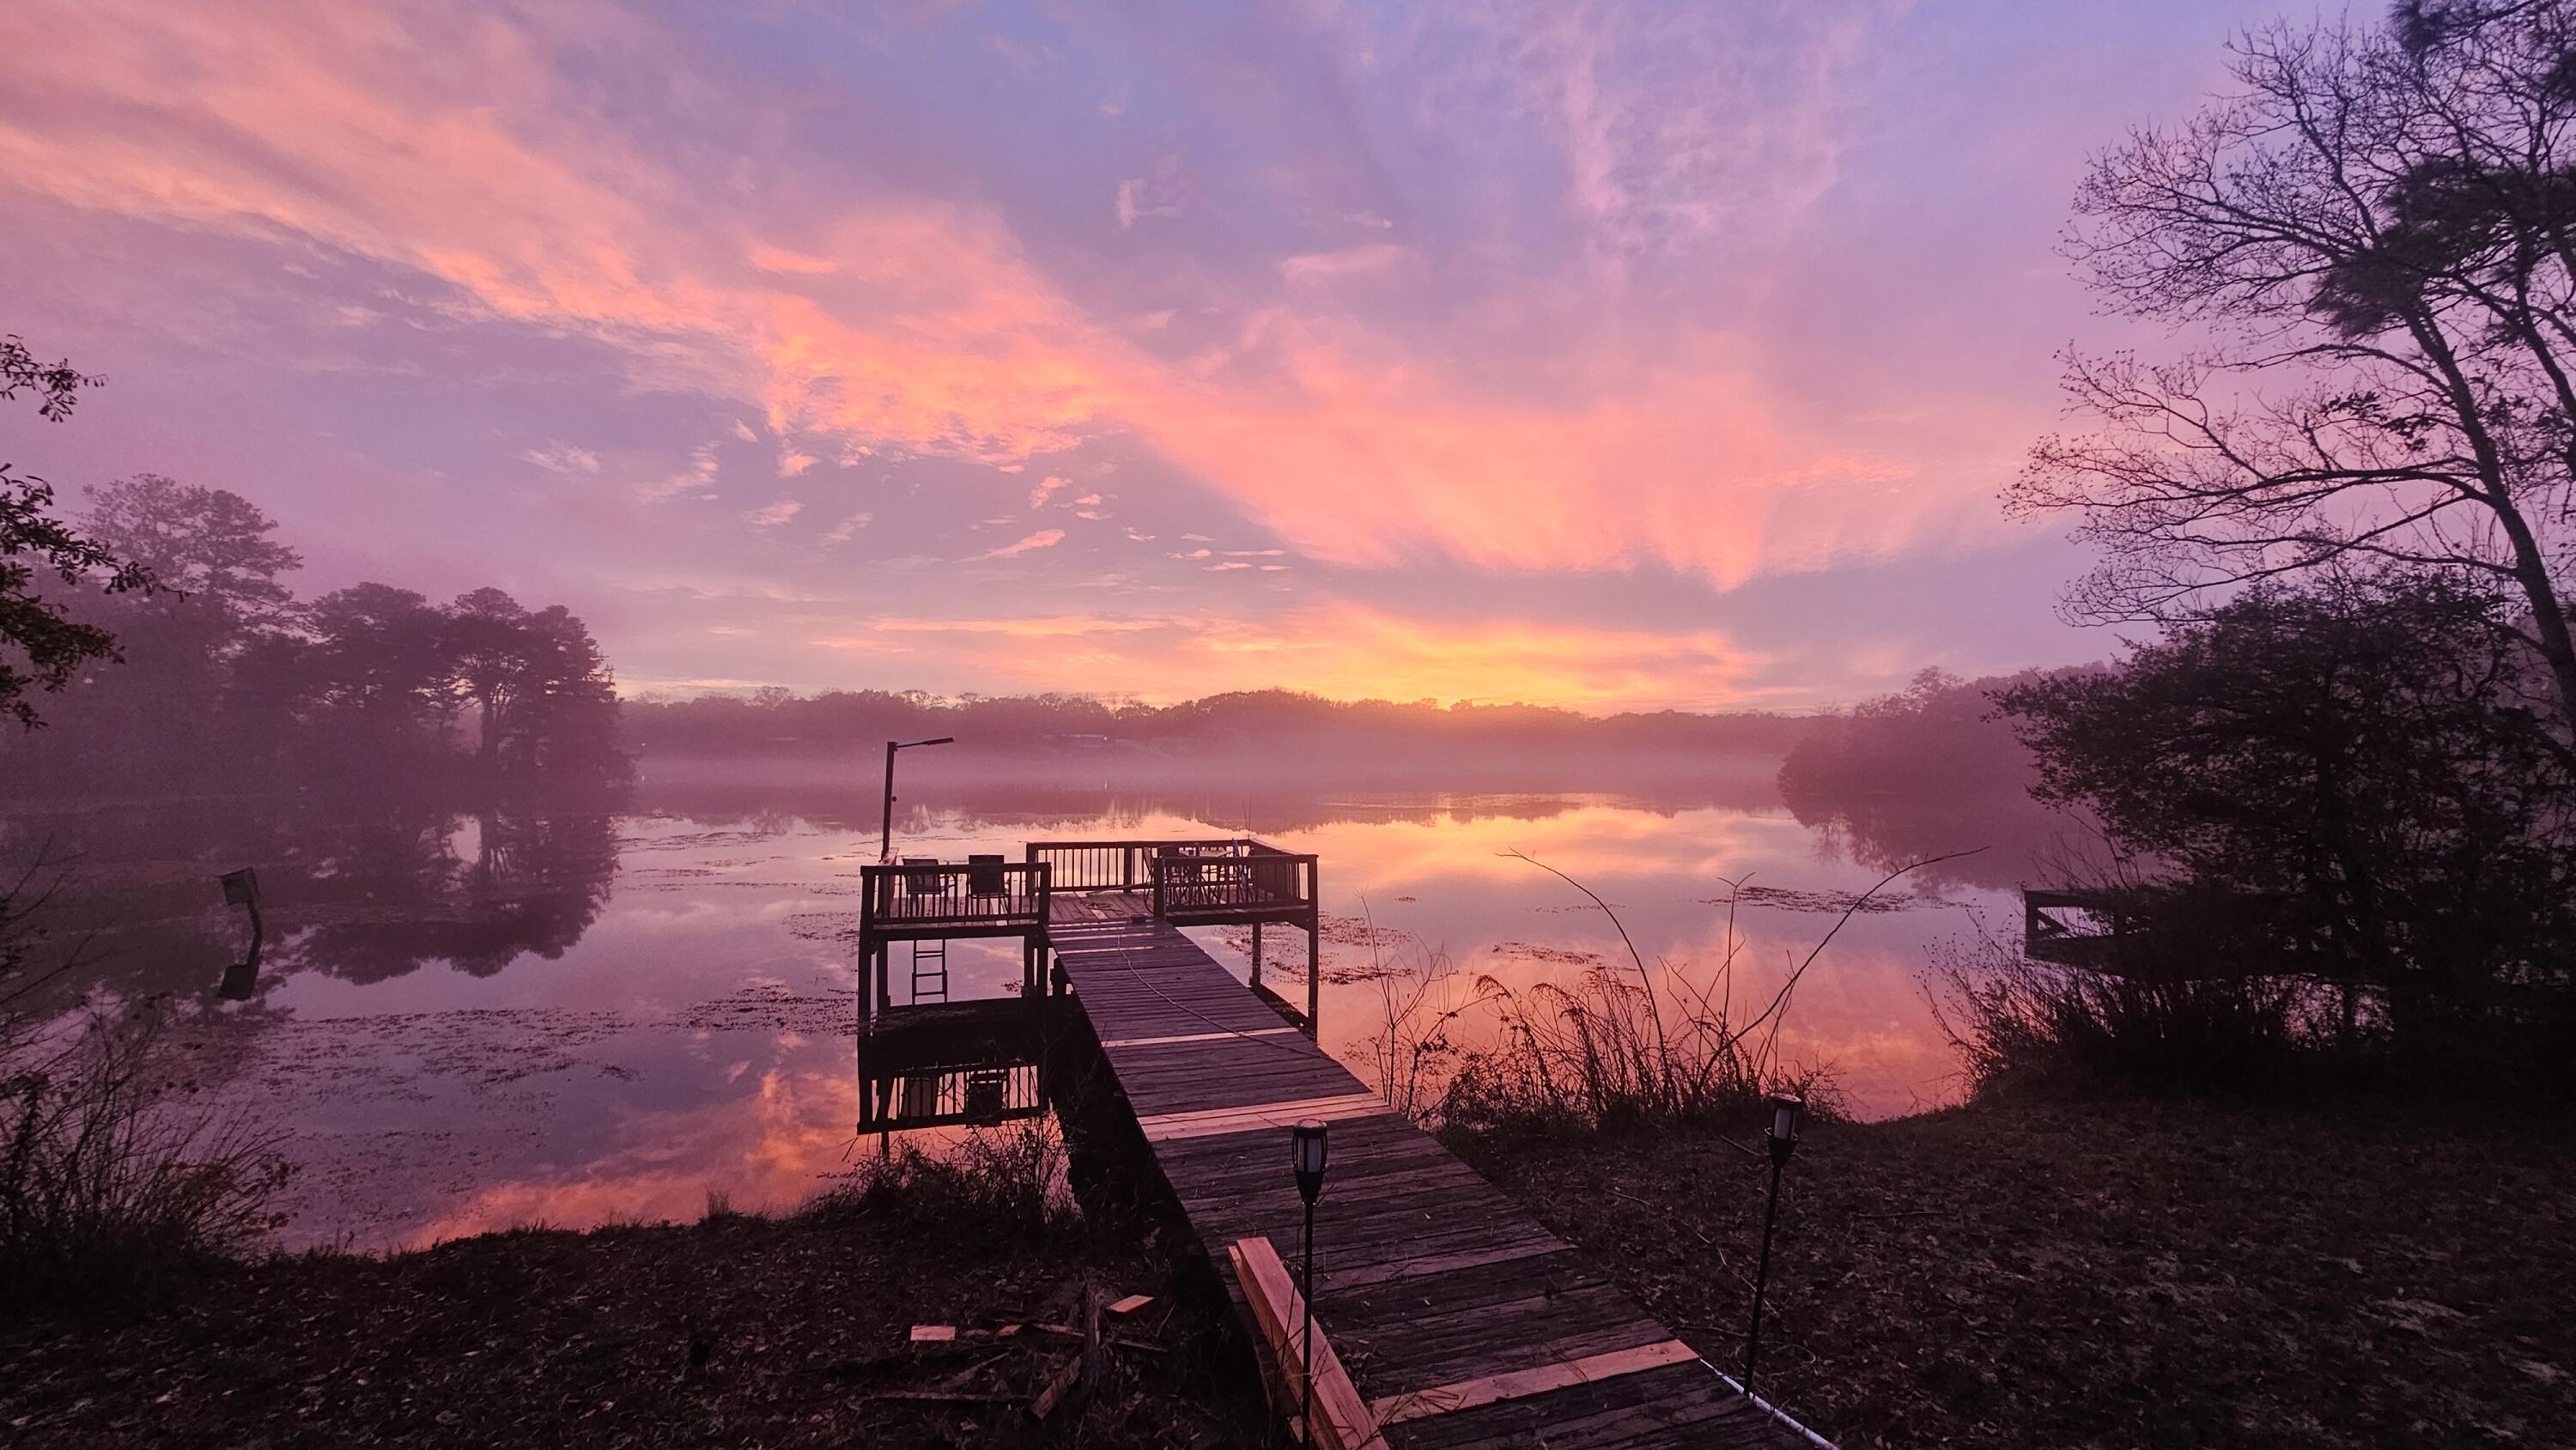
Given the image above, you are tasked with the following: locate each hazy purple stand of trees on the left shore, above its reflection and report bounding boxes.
[0,464,626,793]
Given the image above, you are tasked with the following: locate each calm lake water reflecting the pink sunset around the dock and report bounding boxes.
[5,773,2025,1249]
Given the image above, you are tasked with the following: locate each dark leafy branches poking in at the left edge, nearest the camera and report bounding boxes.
[0,335,152,729]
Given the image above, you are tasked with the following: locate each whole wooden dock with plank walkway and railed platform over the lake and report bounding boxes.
[860,840,1832,1450]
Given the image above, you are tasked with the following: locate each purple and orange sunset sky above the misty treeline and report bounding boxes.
[0,0,2280,711]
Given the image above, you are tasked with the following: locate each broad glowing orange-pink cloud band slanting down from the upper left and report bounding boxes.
[0,0,1991,595]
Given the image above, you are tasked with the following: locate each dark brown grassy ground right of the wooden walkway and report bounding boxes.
[1468,1102,2576,1450]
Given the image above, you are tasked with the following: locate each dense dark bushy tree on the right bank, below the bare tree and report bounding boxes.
[1999,574,2576,1061]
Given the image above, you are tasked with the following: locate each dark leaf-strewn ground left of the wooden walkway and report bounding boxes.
[0,1208,1267,1450]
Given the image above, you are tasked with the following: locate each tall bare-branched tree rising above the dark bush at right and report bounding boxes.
[2007,0,2576,737]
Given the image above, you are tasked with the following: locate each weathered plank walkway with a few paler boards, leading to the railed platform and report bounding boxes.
[1048,894,1821,1450]
